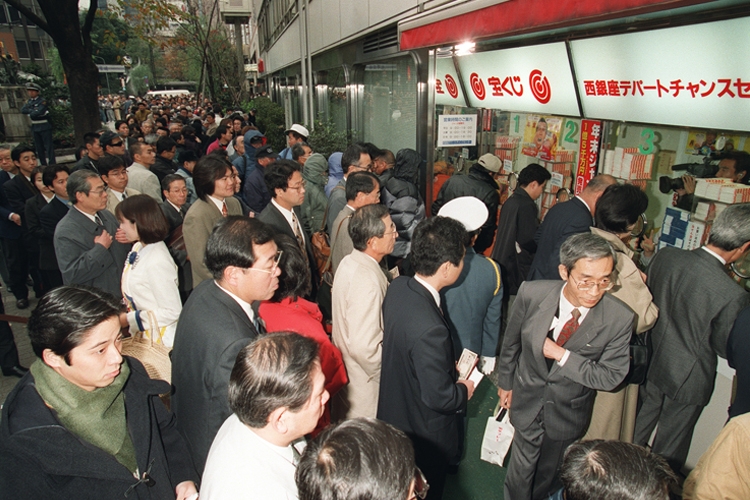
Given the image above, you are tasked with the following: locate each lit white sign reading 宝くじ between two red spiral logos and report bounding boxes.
[458,42,580,116]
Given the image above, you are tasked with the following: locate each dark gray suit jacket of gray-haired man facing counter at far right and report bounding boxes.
[648,248,750,405]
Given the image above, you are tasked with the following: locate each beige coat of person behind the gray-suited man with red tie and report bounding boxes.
[583,227,659,443]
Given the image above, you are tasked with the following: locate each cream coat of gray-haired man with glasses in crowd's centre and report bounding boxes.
[331,250,388,421]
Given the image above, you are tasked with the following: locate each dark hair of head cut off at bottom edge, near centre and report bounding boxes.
[295,418,416,500]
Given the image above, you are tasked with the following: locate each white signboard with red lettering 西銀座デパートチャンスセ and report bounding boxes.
[570,17,750,134]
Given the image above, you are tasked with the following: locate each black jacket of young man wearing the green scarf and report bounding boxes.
[0,357,198,500]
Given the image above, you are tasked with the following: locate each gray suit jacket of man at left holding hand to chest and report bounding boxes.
[54,207,130,297]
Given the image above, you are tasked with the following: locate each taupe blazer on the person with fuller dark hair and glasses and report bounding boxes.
[182,196,242,287]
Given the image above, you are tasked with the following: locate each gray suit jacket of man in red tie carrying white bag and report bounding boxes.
[497,281,634,441]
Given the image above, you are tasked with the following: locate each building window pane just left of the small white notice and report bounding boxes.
[360,56,417,152]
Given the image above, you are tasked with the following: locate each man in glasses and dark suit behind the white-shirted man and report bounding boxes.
[172,216,281,472]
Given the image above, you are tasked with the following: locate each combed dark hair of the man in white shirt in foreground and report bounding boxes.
[229,332,320,428]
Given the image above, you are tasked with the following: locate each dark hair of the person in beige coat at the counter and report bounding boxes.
[594,184,648,234]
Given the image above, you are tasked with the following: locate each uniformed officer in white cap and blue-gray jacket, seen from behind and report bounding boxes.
[437,196,503,374]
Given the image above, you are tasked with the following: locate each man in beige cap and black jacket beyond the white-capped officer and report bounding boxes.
[432,153,502,253]
